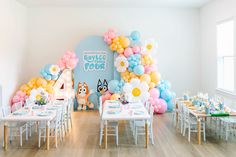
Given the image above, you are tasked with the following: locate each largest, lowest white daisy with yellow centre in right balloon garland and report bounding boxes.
[123,78,150,102]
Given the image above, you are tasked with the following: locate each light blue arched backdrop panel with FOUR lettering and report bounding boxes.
[74,36,120,110]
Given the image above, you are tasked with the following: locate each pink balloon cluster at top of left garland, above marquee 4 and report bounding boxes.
[58,51,78,70]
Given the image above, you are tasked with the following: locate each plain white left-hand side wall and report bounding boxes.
[0,0,27,108]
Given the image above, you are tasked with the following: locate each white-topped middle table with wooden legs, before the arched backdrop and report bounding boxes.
[102,100,150,149]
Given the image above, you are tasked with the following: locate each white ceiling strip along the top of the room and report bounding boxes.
[17,0,212,8]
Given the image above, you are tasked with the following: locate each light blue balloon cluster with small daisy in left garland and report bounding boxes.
[40,64,61,80]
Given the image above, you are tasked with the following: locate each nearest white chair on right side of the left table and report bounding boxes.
[38,108,62,148]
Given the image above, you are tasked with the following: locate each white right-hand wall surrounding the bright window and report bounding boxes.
[200,0,236,106]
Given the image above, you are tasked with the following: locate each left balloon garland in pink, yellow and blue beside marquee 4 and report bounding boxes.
[10,51,78,105]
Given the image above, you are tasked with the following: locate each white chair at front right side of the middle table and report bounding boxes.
[134,105,154,144]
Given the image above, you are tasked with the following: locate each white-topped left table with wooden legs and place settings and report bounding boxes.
[1,105,60,150]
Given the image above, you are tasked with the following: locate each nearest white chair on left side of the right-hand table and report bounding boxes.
[183,105,206,142]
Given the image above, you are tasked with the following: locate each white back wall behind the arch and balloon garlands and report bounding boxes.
[26,7,200,94]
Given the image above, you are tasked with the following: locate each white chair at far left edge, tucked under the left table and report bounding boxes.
[2,106,28,147]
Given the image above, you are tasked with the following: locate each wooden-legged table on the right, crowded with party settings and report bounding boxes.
[176,100,236,145]
